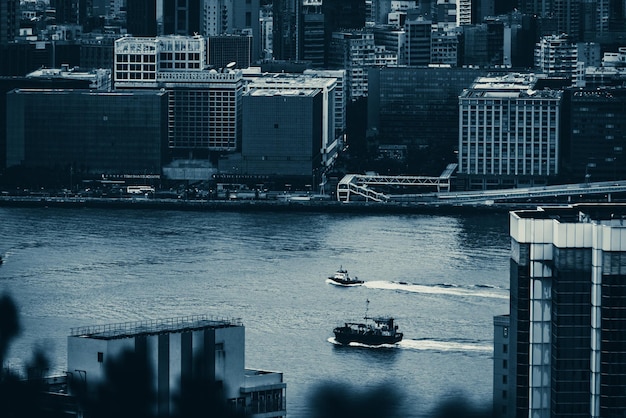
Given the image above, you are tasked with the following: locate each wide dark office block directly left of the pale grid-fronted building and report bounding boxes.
[367,66,485,175]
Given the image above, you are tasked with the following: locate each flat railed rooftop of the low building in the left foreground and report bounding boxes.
[70,315,243,340]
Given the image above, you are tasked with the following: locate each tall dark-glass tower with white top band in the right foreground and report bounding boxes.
[509,204,626,418]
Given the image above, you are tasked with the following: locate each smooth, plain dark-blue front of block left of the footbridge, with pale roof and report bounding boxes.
[238,87,323,179]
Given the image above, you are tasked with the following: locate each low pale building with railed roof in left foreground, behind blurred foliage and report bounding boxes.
[67,315,286,418]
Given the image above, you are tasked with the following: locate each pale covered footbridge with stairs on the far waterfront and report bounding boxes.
[337,163,457,202]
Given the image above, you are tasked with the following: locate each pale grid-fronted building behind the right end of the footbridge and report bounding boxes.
[458,73,563,190]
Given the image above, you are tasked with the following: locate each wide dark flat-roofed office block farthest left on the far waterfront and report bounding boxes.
[6,89,167,178]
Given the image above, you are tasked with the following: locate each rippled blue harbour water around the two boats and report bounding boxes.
[0,208,510,417]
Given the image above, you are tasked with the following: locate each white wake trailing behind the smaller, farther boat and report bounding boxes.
[363,280,509,299]
